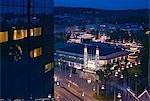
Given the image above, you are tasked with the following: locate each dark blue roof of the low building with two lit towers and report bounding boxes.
[58,42,127,56]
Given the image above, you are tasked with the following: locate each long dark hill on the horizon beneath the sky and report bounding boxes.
[54,7,150,23]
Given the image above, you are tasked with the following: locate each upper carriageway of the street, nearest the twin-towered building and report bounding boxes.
[55,71,97,101]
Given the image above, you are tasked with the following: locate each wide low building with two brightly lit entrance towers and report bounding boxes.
[55,42,129,72]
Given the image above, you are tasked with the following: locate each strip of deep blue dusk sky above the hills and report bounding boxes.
[54,0,150,10]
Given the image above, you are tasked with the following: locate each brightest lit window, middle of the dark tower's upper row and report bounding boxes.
[13,29,27,40]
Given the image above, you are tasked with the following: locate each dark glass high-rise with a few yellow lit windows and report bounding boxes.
[0,0,54,100]
